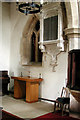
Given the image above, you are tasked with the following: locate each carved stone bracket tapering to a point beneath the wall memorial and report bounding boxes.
[39,42,61,72]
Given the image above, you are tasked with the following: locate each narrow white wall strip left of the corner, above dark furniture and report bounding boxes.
[0,3,10,71]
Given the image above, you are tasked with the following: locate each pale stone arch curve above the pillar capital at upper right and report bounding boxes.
[65,0,79,28]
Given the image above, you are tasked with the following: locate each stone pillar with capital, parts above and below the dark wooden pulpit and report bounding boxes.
[65,28,80,112]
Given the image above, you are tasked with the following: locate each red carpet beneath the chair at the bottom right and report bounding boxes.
[32,113,80,120]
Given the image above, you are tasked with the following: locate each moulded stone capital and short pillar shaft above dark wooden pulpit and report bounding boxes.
[65,28,80,51]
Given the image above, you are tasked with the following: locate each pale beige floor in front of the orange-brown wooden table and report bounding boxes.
[2,95,80,119]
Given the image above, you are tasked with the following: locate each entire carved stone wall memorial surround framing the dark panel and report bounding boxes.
[39,2,64,71]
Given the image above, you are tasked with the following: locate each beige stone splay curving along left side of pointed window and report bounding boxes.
[20,15,39,65]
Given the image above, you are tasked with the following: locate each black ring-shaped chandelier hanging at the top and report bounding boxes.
[16,0,43,15]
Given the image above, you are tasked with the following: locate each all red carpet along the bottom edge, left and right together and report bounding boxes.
[1,110,80,120]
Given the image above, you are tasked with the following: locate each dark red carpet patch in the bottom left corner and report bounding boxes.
[1,110,24,120]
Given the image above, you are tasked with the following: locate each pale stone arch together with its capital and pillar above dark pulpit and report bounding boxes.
[64,0,80,50]
